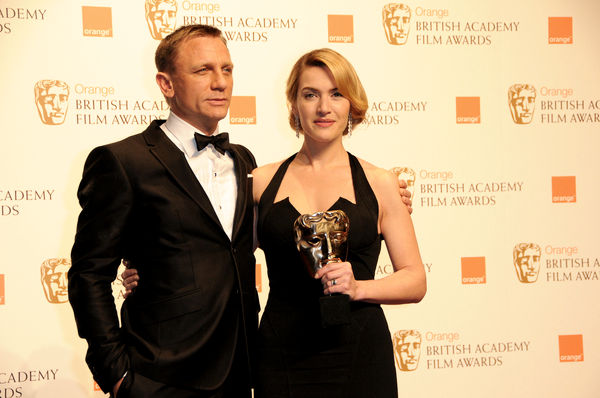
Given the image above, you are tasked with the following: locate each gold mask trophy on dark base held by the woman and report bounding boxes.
[294,210,350,327]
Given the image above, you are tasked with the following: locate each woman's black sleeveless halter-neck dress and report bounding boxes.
[255,154,398,398]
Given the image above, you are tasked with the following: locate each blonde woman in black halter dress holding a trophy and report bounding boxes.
[253,49,426,398]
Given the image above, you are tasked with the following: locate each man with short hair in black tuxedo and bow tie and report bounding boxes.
[69,25,259,398]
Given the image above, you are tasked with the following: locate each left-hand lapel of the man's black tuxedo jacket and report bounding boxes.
[144,121,225,233]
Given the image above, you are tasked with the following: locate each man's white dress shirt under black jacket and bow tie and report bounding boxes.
[160,112,238,239]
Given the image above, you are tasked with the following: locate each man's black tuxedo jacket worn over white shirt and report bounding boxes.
[69,121,259,392]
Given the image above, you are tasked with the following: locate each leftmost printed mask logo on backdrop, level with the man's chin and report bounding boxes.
[33,80,69,125]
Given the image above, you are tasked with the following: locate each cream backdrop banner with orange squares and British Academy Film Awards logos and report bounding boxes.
[0,0,600,398]
